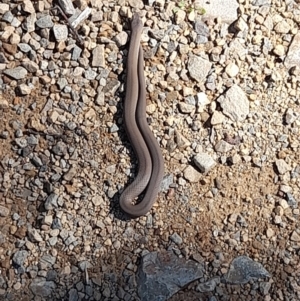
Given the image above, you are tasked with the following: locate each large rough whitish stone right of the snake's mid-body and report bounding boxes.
[217,85,249,121]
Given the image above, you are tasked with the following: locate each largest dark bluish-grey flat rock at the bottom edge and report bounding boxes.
[137,251,204,301]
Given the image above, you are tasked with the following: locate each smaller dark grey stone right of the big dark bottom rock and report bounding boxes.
[222,256,271,284]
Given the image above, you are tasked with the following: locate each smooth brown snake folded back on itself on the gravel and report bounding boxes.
[120,13,164,217]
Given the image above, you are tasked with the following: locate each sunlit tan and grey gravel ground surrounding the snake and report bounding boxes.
[0,0,300,301]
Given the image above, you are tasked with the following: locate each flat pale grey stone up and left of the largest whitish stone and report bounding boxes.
[188,55,212,82]
